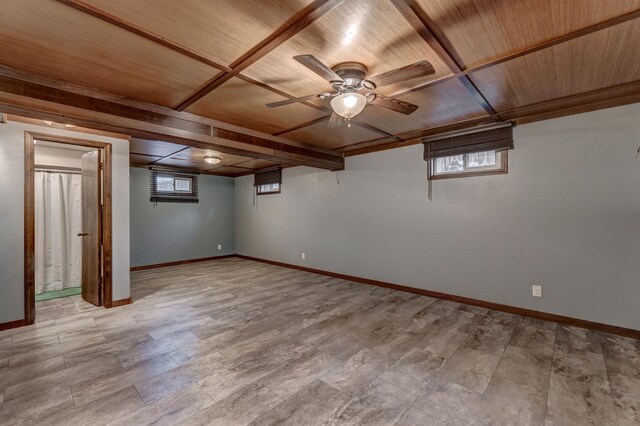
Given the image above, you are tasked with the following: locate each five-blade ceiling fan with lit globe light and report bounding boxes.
[266,55,436,127]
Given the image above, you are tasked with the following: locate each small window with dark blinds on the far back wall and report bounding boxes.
[150,170,198,203]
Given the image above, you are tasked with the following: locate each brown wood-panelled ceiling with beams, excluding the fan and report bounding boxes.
[0,0,640,176]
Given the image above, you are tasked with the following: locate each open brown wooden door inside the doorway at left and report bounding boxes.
[78,149,102,306]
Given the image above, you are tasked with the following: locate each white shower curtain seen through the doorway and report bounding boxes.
[35,172,82,294]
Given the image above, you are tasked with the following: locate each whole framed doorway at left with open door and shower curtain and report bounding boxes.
[24,132,112,324]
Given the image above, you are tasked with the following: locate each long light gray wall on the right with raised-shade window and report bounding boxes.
[236,104,640,329]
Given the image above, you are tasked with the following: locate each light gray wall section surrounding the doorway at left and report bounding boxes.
[0,122,129,323]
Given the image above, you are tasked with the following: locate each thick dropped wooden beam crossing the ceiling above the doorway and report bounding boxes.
[0,69,344,170]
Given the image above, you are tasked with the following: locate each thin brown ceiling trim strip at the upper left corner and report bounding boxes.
[55,0,231,71]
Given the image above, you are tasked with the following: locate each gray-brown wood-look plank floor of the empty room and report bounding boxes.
[0,258,640,426]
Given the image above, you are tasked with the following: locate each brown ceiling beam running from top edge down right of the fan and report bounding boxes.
[391,0,499,120]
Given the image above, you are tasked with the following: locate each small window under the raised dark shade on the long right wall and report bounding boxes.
[429,150,508,179]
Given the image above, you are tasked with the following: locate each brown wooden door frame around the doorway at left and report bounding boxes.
[24,131,113,325]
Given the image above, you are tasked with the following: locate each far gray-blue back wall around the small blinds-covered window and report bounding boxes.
[130,168,235,266]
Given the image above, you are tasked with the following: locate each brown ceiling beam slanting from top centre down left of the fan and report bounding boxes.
[175,0,345,111]
